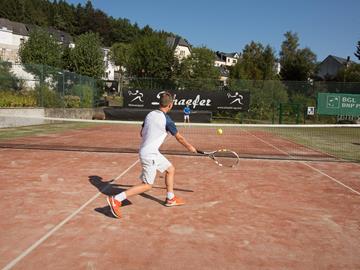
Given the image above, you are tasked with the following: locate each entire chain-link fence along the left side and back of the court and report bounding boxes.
[0,62,360,123]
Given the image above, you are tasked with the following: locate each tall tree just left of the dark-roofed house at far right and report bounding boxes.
[280,32,316,81]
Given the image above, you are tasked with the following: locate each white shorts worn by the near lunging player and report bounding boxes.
[140,154,171,185]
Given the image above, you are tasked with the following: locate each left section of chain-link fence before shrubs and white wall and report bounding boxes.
[0,62,102,108]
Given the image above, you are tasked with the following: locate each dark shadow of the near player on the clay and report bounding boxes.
[89,175,164,217]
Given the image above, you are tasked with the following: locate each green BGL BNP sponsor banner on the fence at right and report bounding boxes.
[317,93,360,116]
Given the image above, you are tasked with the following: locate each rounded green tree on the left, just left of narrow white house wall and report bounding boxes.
[68,33,105,78]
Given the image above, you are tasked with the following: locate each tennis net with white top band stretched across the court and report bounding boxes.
[0,116,360,162]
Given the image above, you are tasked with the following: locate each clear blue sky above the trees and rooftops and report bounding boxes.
[67,0,360,62]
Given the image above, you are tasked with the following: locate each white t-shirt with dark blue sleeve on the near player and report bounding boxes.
[139,110,178,158]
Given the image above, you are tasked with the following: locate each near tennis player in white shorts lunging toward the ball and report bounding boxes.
[107,92,196,218]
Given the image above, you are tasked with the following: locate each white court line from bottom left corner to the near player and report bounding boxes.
[2,159,139,270]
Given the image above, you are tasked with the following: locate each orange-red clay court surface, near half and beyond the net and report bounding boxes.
[0,121,360,269]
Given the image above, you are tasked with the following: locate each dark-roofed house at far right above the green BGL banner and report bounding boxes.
[317,55,353,79]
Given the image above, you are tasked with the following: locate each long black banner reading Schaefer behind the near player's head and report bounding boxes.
[123,89,250,111]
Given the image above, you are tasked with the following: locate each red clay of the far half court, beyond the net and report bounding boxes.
[0,124,334,160]
